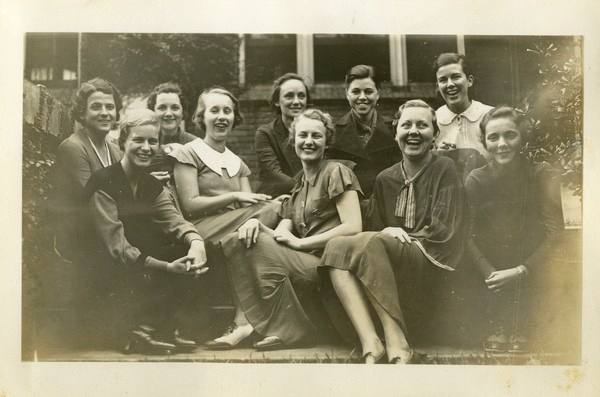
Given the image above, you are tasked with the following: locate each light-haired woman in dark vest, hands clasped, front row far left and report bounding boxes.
[84,109,208,353]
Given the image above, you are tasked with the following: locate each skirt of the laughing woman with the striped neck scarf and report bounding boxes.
[319,232,442,343]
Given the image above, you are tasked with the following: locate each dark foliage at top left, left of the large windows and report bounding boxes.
[82,33,239,128]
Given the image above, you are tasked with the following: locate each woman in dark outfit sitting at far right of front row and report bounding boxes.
[465,107,564,352]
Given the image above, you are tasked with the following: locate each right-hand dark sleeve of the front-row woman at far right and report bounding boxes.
[523,166,564,270]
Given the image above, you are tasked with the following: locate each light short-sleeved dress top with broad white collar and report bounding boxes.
[169,138,251,221]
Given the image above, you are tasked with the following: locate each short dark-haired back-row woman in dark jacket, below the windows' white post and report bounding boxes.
[327,65,402,198]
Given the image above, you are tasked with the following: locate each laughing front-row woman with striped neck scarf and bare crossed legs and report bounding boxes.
[321,100,466,364]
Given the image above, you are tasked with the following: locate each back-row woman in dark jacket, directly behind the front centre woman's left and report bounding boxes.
[255,73,310,197]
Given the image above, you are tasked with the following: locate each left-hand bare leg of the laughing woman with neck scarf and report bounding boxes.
[329,268,384,363]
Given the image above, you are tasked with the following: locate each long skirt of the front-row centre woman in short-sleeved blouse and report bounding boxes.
[221,233,320,345]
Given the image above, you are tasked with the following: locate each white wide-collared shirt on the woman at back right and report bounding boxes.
[435,101,492,158]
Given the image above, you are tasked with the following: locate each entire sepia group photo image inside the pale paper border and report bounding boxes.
[22,32,584,365]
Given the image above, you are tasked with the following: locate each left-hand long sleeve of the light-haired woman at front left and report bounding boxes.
[89,190,167,267]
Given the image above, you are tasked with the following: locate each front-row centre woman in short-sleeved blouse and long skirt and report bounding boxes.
[222,109,362,350]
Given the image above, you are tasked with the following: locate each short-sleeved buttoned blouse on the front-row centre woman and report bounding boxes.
[280,160,362,238]
